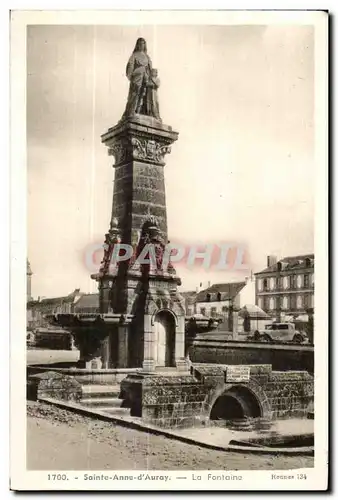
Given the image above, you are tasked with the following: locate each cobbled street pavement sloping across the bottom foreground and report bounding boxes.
[27,402,314,471]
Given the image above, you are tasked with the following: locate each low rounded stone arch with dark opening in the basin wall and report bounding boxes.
[208,381,271,419]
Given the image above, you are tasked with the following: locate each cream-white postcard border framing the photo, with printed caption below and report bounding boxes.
[10,7,328,491]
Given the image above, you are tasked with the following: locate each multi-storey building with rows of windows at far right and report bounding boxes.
[255,254,315,321]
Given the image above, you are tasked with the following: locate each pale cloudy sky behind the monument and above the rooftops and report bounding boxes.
[27,25,315,297]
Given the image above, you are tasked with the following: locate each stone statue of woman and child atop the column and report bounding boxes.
[122,38,161,120]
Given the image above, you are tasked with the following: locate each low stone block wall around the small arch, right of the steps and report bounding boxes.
[121,364,314,427]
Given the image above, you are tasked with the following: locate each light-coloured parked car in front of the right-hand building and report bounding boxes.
[248,323,309,344]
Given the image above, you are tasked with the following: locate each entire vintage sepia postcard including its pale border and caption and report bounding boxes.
[10,10,328,491]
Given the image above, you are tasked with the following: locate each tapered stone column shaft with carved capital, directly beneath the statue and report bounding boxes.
[102,115,178,244]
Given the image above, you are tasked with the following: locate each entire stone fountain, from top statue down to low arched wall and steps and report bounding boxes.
[44,39,313,430]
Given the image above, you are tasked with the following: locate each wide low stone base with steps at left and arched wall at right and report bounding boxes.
[27,363,313,435]
